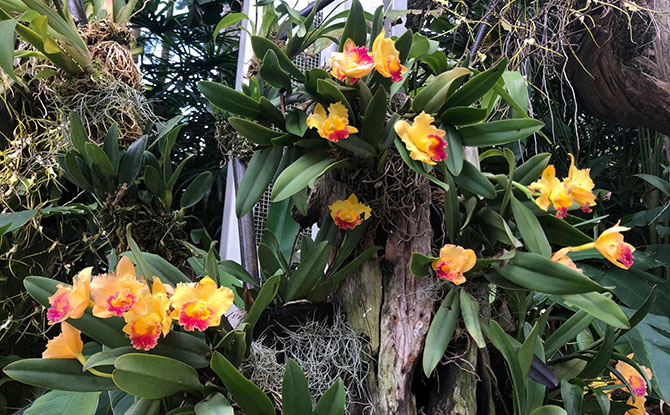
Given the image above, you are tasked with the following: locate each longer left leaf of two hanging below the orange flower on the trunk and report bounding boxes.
[422,288,461,377]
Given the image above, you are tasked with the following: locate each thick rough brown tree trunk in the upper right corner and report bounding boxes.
[567,0,670,135]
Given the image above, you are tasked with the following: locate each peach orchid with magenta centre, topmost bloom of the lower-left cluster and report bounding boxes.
[91,257,149,318]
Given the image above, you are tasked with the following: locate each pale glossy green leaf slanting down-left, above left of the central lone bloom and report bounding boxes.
[272,150,335,202]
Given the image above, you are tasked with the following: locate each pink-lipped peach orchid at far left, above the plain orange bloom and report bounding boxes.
[47,267,92,324]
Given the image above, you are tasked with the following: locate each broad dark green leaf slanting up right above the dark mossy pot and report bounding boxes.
[284,241,330,301]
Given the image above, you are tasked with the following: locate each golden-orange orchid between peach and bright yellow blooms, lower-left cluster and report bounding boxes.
[123,277,172,350]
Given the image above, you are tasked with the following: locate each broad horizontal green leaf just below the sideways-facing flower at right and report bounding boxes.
[498,252,603,295]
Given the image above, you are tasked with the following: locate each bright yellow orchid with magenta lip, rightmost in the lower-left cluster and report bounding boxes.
[170,277,234,331]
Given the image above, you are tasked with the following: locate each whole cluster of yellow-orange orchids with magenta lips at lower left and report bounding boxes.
[43,257,234,358]
